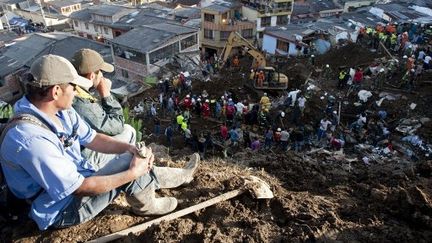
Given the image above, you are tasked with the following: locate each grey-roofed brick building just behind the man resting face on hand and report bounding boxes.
[111,23,199,82]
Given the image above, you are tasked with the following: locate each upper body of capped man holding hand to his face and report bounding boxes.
[72,49,125,139]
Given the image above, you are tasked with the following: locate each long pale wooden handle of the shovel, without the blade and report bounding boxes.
[88,189,246,243]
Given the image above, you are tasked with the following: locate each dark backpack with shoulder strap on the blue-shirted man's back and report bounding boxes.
[0,113,51,224]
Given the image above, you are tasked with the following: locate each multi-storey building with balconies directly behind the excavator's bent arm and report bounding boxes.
[200,2,256,56]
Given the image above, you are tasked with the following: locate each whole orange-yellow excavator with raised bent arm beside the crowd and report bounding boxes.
[220,31,288,89]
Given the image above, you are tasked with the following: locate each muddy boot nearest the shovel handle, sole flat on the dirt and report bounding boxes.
[126,183,177,216]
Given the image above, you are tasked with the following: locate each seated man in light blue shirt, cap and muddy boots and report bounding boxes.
[0,55,199,230]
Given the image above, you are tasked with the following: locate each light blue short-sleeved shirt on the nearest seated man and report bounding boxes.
[0,97,96,229]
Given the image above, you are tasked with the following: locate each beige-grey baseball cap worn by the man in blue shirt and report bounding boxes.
[28,54,93,89]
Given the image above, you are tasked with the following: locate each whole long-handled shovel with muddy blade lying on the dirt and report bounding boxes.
[88,176,273,243]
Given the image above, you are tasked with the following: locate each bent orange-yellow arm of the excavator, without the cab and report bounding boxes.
[220,31,266,68]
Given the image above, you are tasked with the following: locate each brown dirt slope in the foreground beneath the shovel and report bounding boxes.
[3,152,432,242]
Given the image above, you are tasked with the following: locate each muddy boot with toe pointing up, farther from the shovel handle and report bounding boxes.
[152,153,200,188]
